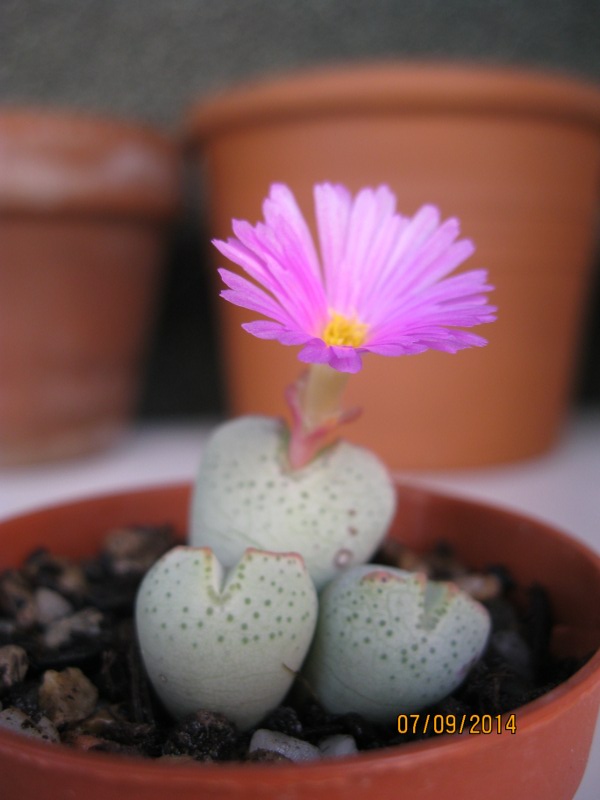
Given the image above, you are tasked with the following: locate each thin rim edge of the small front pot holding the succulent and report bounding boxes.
[0,478,600,788]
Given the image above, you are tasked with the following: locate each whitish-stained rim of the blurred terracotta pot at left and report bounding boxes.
[0,105,182,218]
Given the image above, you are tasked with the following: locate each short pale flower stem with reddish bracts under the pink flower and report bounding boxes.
[286,364,360,469]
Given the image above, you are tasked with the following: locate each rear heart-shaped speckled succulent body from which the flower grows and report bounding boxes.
[190,417,396,588]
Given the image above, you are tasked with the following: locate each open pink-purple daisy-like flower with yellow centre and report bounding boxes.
[214,183,496,372]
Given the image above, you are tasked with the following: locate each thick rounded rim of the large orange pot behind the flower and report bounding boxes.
[184,59,600,146]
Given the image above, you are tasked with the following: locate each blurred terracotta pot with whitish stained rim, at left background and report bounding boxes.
[0,109,179,464]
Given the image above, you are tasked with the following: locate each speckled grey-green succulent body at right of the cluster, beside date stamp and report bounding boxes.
[303,565,490,723]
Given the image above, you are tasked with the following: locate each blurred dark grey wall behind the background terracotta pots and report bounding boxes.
[0,0,600,416]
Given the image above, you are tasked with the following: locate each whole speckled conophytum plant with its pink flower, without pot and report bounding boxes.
[136,183,496,728]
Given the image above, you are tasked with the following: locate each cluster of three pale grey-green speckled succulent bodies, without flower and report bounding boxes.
[136,417,489,729]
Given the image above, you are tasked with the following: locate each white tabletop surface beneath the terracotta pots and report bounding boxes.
[0,413,600,800]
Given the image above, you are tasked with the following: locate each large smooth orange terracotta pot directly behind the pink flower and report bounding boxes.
[187,63,600,468]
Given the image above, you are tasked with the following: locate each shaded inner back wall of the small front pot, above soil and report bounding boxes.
[0,483,600,657]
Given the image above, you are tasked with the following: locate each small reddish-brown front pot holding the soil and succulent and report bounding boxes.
[0,486,600,800]
